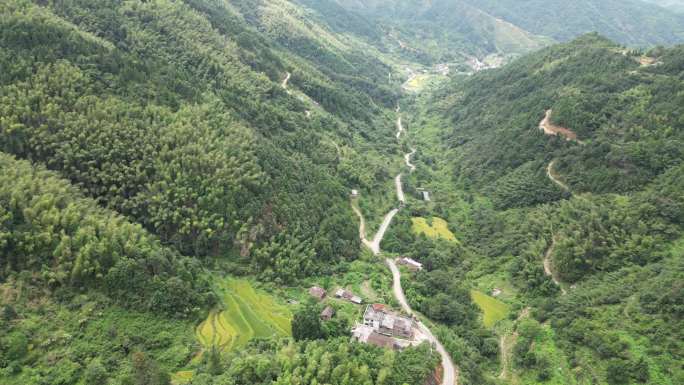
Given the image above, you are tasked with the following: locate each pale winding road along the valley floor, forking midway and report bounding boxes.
[352,107,458,385]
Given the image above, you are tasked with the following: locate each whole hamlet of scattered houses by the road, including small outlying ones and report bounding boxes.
[309,257,427,350]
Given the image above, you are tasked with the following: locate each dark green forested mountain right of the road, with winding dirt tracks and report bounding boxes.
[398,34,684,384]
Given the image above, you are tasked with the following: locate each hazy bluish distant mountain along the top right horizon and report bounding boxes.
[332,0,684,63]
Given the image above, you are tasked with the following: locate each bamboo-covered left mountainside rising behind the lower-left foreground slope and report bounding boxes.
[0,1,396,273]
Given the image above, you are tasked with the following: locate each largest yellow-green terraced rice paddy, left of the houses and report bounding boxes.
[196,279,292,351]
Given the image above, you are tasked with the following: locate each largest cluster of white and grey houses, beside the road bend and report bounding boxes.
[352,303,415,350]
